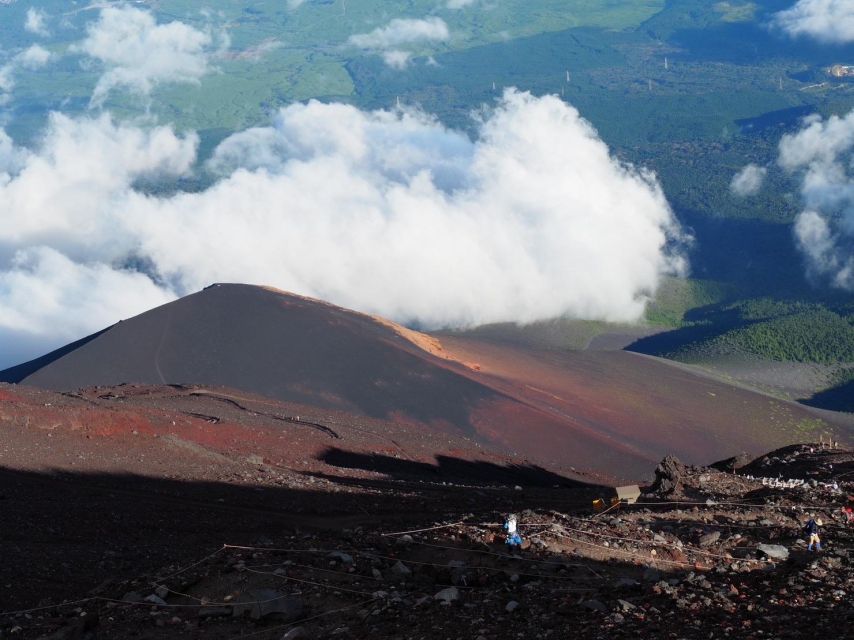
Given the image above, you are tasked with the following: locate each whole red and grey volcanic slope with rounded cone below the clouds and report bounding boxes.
[0,285,846,479]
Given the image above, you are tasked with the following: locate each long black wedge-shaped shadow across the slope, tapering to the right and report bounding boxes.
[0,459,592,610]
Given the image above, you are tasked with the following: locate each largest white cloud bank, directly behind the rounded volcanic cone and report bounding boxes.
[0,91,684,364]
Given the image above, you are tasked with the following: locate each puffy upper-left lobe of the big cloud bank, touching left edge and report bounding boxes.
[0,114,198,256]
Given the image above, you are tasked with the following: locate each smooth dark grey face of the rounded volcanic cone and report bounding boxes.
[0,284,499,429]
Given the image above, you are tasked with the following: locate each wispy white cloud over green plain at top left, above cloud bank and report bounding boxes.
[73,6,214,106]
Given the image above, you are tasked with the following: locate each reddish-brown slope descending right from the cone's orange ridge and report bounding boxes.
[432,337,847,473]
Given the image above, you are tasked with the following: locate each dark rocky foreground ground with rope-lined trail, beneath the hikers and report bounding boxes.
[0,445,854,640]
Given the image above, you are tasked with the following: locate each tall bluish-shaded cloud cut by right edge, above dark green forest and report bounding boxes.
[777,110,854,291]
